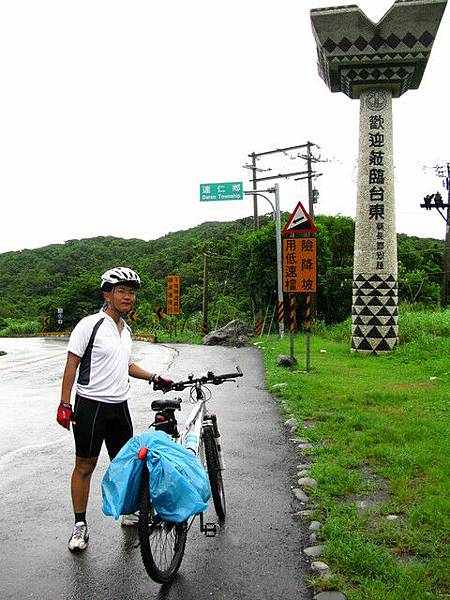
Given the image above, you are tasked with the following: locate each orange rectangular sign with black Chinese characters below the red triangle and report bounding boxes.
[283,238,317,294]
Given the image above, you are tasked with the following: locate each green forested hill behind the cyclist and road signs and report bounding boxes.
[0,214,443,326]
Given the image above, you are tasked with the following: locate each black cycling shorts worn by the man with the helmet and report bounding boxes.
[73,394,133,460]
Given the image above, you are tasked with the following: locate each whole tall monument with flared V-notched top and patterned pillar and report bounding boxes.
[311,0,447,354]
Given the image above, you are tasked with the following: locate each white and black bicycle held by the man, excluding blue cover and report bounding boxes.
[138,366,243,583]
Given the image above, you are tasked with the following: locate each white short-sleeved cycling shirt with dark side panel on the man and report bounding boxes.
[68,311,132,403]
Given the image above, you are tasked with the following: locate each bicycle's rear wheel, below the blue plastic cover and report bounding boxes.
[138,466,187,583]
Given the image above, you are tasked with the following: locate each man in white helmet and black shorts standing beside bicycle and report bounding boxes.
[56,267,172,551]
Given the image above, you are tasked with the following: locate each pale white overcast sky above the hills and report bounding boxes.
[0,0,450,252]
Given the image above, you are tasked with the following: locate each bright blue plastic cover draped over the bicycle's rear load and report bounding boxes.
[102,431,211,523]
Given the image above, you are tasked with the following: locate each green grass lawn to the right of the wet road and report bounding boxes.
[257,311,450,600]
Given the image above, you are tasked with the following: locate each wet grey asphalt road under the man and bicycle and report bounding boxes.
[0,338,311,600]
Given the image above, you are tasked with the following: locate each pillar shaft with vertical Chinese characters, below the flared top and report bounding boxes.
[352,89,398,354]
